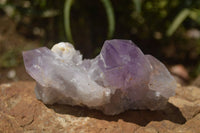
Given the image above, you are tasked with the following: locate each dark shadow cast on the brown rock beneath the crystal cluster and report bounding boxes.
[46,103,186,126]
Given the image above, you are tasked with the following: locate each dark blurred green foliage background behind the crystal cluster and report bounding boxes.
[0,0,200,76]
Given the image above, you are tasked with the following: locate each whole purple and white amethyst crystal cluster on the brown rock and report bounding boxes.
[23,39,176,115]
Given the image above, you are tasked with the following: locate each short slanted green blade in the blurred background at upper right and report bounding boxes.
[166,8,190,36]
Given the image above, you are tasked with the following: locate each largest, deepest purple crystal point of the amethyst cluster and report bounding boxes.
[99,39,151,100]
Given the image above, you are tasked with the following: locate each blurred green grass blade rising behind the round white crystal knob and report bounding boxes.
[64,0,74,44]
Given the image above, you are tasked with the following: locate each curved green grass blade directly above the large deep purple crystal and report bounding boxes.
[101,0,115,39]
